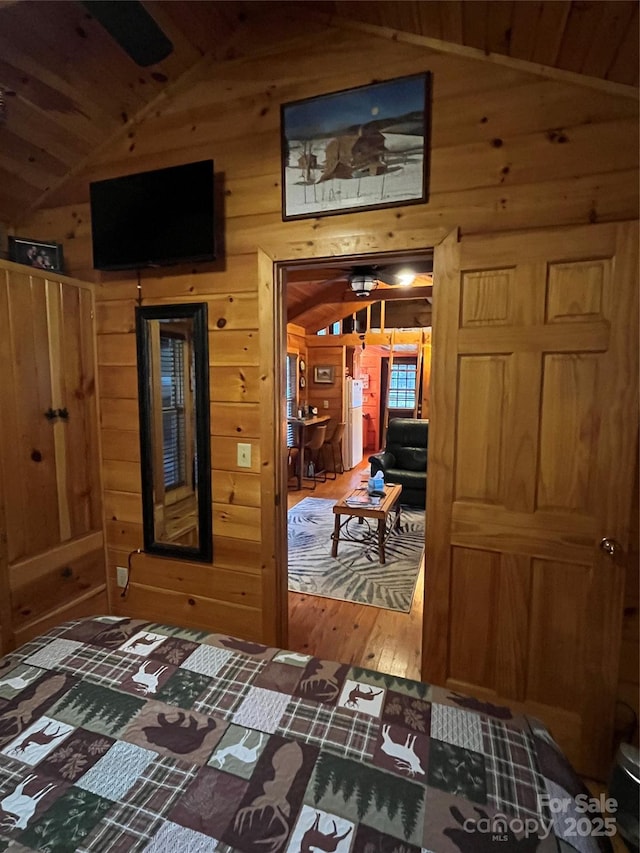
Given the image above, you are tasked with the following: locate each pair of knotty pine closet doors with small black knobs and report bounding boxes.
[0,270,101,565]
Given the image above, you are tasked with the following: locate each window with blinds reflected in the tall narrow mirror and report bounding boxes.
[160,333,187,491]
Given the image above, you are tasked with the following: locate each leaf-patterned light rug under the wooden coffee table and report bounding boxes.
[288,498,424,613]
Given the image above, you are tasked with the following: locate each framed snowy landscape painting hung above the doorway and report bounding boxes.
[280,73,431,221]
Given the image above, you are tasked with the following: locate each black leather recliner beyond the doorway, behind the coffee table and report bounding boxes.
[369,418,429,507]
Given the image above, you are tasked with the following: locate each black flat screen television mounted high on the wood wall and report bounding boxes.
[89,160,216,270]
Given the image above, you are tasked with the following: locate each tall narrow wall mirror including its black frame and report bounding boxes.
[136,302,213,562]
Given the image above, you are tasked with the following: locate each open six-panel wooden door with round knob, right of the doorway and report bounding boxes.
[423,223,638,778]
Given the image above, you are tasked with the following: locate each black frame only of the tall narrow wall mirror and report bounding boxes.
[136,302,213,563]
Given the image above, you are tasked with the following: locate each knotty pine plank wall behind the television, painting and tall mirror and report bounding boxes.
[16,13,638,640]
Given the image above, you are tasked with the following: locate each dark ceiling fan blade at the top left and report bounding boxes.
[82,0,173,68]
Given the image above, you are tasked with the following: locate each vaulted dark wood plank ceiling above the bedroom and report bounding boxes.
[0,0,638,225]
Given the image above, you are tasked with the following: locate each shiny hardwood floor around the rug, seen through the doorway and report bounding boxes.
[288,452,424,680]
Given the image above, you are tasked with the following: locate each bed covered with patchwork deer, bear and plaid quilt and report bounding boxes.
[0,616,609,853]
